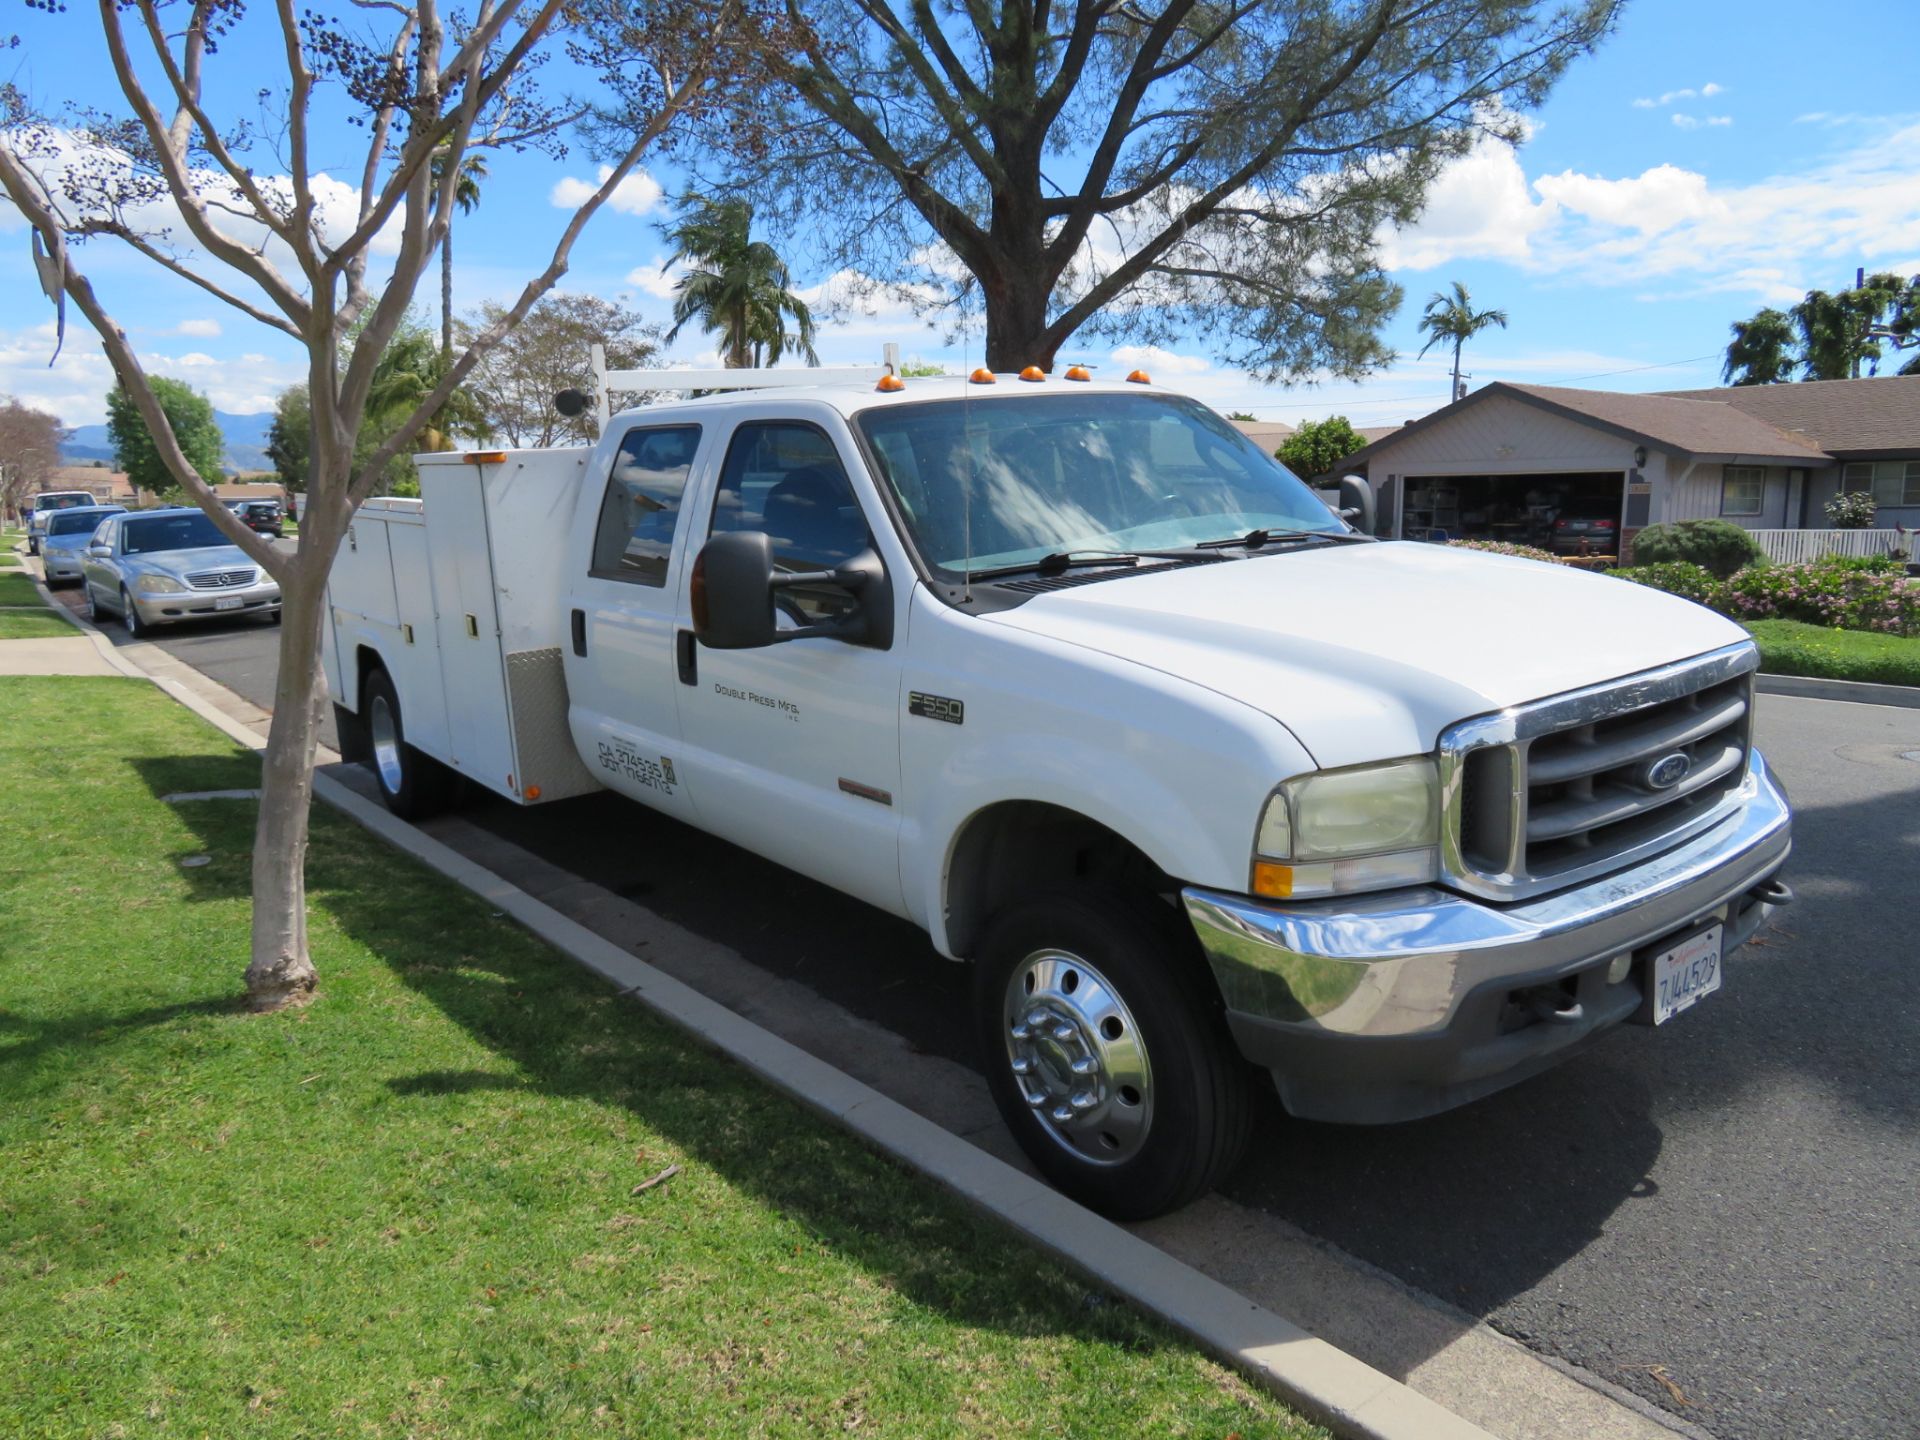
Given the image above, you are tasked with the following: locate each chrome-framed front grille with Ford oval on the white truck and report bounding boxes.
[1440,645,1759,900]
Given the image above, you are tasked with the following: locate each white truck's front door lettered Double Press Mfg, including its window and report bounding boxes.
[680,419,912,914]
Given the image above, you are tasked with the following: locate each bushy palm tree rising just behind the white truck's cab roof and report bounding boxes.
[662,196,820,371]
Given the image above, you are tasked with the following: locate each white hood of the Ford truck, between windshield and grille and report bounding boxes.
[987,541,1747,768]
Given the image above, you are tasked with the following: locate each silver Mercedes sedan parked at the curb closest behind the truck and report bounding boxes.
[81,505,280,636]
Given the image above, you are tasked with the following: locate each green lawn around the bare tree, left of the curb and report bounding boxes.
[0,680,1319,1438]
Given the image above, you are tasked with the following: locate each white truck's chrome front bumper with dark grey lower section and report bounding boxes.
[1183,751,1791,1121]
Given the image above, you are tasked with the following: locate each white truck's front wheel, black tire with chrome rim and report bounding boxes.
[973,885,1250,1219]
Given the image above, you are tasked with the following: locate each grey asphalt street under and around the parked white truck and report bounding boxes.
[56,572,1920,1440]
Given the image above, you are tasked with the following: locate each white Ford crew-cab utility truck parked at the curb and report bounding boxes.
[324,371,1791,1215]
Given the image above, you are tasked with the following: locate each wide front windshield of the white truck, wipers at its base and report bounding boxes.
[858,392,1344,576]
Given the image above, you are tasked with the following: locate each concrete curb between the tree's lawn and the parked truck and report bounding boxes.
[71,605,1494,1440]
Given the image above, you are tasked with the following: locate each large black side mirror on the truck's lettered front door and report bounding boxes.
[689,530,893,651]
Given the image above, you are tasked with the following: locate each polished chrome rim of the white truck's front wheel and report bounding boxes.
[1000,950,1154,1165]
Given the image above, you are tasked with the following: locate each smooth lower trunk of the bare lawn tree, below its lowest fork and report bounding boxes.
[246,552,332,1010]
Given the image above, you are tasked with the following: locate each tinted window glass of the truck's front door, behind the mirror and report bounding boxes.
[708,420,872,620]
